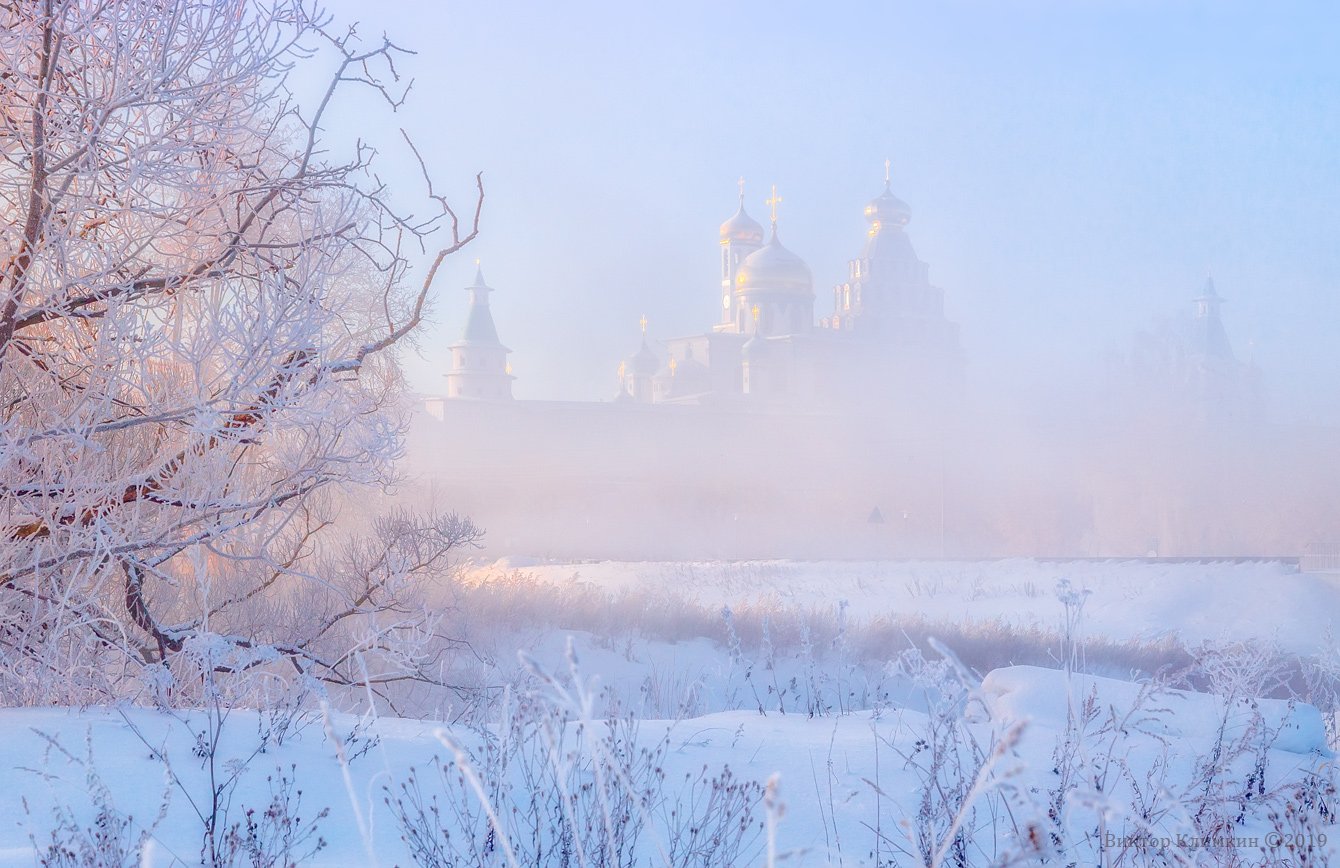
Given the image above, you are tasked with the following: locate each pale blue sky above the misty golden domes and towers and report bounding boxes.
[331,0,1340,419]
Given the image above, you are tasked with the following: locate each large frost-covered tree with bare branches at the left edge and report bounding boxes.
[0,0,482,702]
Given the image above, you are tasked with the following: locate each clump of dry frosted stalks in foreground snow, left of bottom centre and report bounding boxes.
[385,646,764,868]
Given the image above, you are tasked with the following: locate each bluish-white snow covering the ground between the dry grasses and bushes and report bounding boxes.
[0,560,1340,868]
